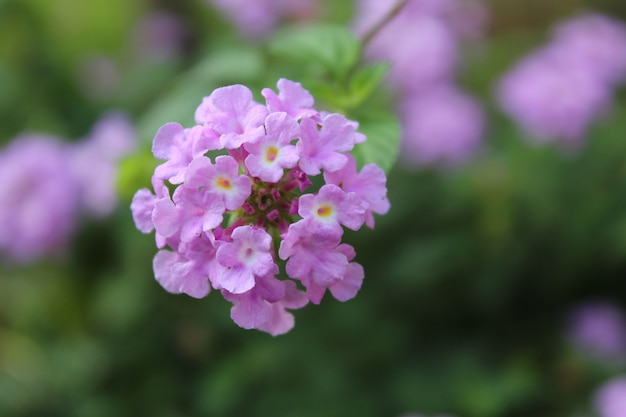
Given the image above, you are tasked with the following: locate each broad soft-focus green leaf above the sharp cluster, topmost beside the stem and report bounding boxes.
[269,24,361,80]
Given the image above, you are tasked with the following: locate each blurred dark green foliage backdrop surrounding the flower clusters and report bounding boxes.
[0,0,626,417]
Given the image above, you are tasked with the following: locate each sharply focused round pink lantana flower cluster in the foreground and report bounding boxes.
[131,79,389,335]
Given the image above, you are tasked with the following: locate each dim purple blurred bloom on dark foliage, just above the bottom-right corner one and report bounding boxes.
[567,301,626,361]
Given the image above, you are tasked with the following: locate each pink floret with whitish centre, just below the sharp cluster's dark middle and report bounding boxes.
[213,226,275,294]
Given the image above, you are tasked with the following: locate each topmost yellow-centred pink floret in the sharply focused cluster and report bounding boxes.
[244,112,300,182]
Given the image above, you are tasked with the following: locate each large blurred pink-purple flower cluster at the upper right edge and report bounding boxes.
[497,14,626,148]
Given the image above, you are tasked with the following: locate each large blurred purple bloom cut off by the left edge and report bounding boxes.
[0,134,79,262]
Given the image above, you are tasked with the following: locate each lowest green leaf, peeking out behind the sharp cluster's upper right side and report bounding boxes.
[353,113,400,172]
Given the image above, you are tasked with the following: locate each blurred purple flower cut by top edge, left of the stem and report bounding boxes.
[208,0,319,38]
